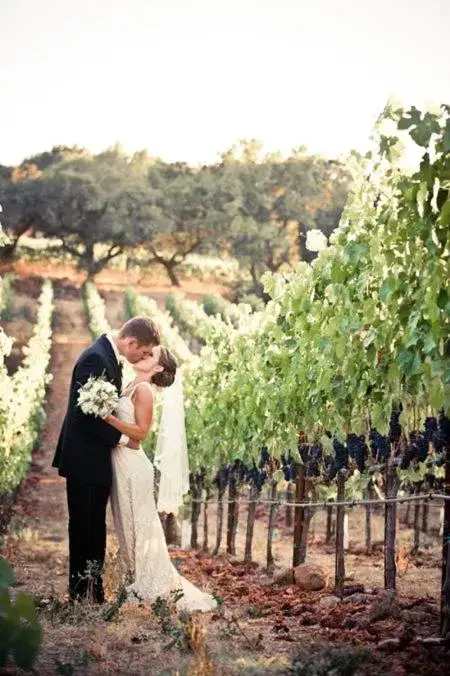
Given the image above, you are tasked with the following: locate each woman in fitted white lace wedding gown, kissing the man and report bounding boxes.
[101,346,217,611]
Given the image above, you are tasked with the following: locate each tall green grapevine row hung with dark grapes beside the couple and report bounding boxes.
[147,107,450,621]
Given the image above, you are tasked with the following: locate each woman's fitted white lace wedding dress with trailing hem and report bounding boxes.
[111,384,217,611]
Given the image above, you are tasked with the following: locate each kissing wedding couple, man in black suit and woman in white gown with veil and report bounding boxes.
[53,317,217,611]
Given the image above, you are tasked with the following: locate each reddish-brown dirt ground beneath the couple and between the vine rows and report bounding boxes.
[2,280,450,676]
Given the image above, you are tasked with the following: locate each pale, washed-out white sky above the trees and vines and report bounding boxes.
[0,0,450,164]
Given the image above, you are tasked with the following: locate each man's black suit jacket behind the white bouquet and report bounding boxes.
[53,336,122,486]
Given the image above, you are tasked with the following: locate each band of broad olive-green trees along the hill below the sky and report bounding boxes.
[0,141,350,293]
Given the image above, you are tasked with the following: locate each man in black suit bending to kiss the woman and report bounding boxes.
[53,317,160,603]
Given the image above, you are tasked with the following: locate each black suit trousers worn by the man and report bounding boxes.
[67,477,110,603]
